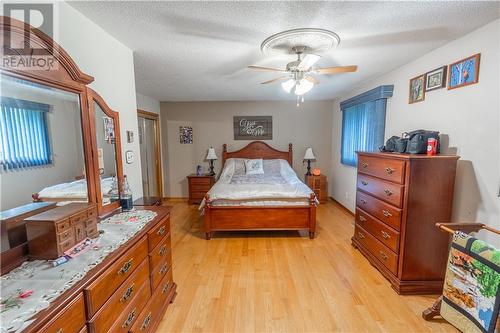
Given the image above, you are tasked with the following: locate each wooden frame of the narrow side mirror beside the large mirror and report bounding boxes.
[87,87,123,214]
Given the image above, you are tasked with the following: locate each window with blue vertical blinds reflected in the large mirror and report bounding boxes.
[0,97,52,170]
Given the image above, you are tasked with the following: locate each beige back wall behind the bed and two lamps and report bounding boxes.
[161,101,332,197]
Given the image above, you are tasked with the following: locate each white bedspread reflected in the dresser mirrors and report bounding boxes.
[38,177,113,199]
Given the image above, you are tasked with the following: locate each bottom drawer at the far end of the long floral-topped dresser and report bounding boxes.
[130,270,173,333]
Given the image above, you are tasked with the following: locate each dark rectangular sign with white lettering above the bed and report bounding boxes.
[233,116,273,140]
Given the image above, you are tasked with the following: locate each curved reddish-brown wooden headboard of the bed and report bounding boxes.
[222,141,293,166]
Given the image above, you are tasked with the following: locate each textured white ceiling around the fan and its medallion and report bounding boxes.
[70,1,500,101]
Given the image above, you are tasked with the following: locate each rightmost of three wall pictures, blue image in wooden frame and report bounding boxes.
[448,53,481,90]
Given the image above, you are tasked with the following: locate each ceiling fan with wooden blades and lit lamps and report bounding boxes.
[248,46,358,96]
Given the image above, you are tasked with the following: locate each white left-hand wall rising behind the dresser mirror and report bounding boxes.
[57,2,142,198]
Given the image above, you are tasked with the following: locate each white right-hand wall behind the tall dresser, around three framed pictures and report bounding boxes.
[329,20,500,241]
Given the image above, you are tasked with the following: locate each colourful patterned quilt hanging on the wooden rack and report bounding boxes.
[441,232,500,332]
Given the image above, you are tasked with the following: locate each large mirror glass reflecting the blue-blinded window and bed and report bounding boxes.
[0,74,89,211]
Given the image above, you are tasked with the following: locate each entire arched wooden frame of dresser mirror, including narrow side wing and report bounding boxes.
[0,16,123,215]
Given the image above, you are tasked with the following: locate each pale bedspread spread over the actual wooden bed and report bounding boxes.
[200,159,313,208]
